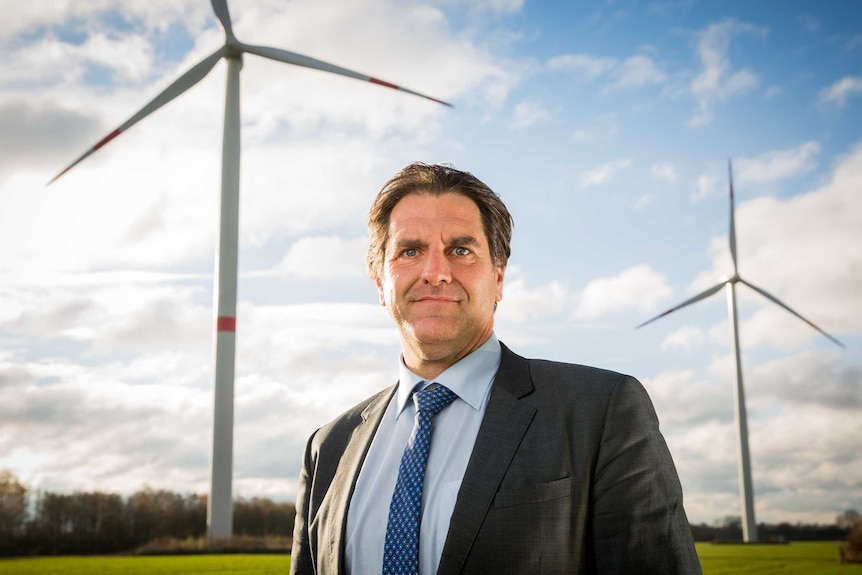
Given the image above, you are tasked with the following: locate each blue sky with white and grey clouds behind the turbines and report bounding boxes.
[0,0,862,524]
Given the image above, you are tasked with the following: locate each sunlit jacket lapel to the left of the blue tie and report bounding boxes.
[320,385,398,573]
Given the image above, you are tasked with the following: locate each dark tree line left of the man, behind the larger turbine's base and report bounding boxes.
[0,471,296,556]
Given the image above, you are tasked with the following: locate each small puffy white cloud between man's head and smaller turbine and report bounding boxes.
[573,264,671,320]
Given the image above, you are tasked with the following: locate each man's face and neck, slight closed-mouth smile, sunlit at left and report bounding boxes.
[376,193,505,369]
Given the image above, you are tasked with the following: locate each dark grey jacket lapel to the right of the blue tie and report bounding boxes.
[437,344,536,573]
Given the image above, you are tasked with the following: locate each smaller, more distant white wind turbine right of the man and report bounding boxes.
[637,160,844,543]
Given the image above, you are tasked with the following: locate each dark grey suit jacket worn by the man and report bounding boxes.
[291,346,701,575]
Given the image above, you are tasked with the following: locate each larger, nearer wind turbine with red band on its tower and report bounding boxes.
[48,0,451,538]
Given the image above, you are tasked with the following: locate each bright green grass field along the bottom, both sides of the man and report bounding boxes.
[0,543,862,575]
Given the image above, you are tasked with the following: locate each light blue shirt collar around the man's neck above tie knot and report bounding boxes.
[396,332,503,418]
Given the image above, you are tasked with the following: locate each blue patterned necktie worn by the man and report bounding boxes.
[383,385,458,575]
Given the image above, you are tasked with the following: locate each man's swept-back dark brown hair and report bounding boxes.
[365,162,514,279]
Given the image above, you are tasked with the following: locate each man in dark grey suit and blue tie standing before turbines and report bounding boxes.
[291,163,700,575]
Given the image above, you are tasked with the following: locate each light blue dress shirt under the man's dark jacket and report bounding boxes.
[345,333,501,575]
